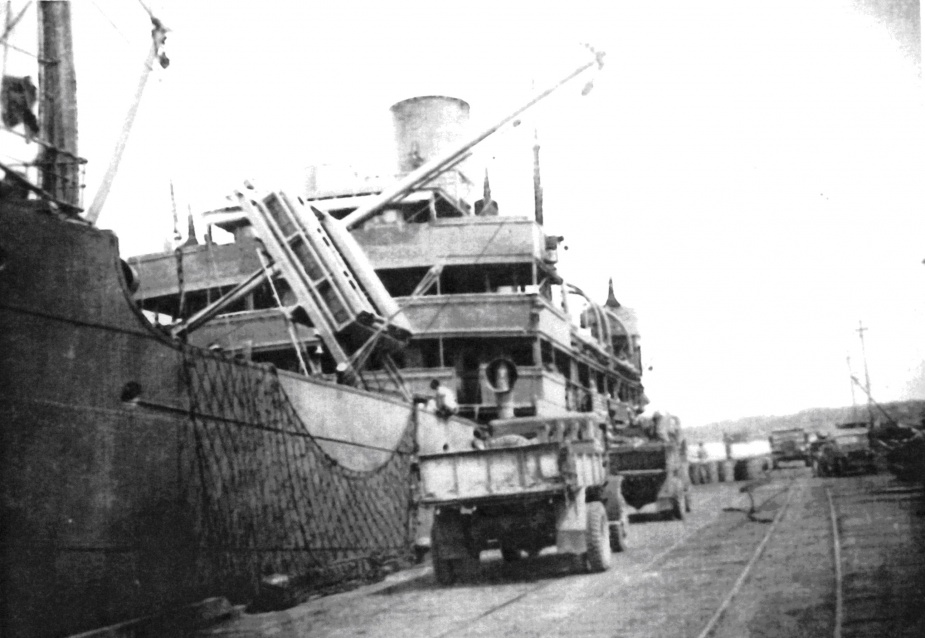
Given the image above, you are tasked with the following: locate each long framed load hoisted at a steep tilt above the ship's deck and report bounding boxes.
[235,188,411,392]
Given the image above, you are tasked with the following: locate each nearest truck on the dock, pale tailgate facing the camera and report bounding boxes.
[419,416,627,584]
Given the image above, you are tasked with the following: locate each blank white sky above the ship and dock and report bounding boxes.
[0,0,925,426]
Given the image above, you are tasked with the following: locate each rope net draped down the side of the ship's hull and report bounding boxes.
[180,354,416,607]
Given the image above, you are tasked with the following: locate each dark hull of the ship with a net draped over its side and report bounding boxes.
[0,204,471,636]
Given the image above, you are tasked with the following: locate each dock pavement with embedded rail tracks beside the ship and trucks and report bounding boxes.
[197,476,925,638]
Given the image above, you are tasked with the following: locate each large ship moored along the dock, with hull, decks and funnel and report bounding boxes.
[0,2,645,637]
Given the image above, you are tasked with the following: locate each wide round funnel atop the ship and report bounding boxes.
[390,95,469,173]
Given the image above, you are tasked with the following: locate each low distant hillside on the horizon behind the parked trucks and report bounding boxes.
[682,400,925,441]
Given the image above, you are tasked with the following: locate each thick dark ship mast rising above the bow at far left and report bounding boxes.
[37,0,82,207]
